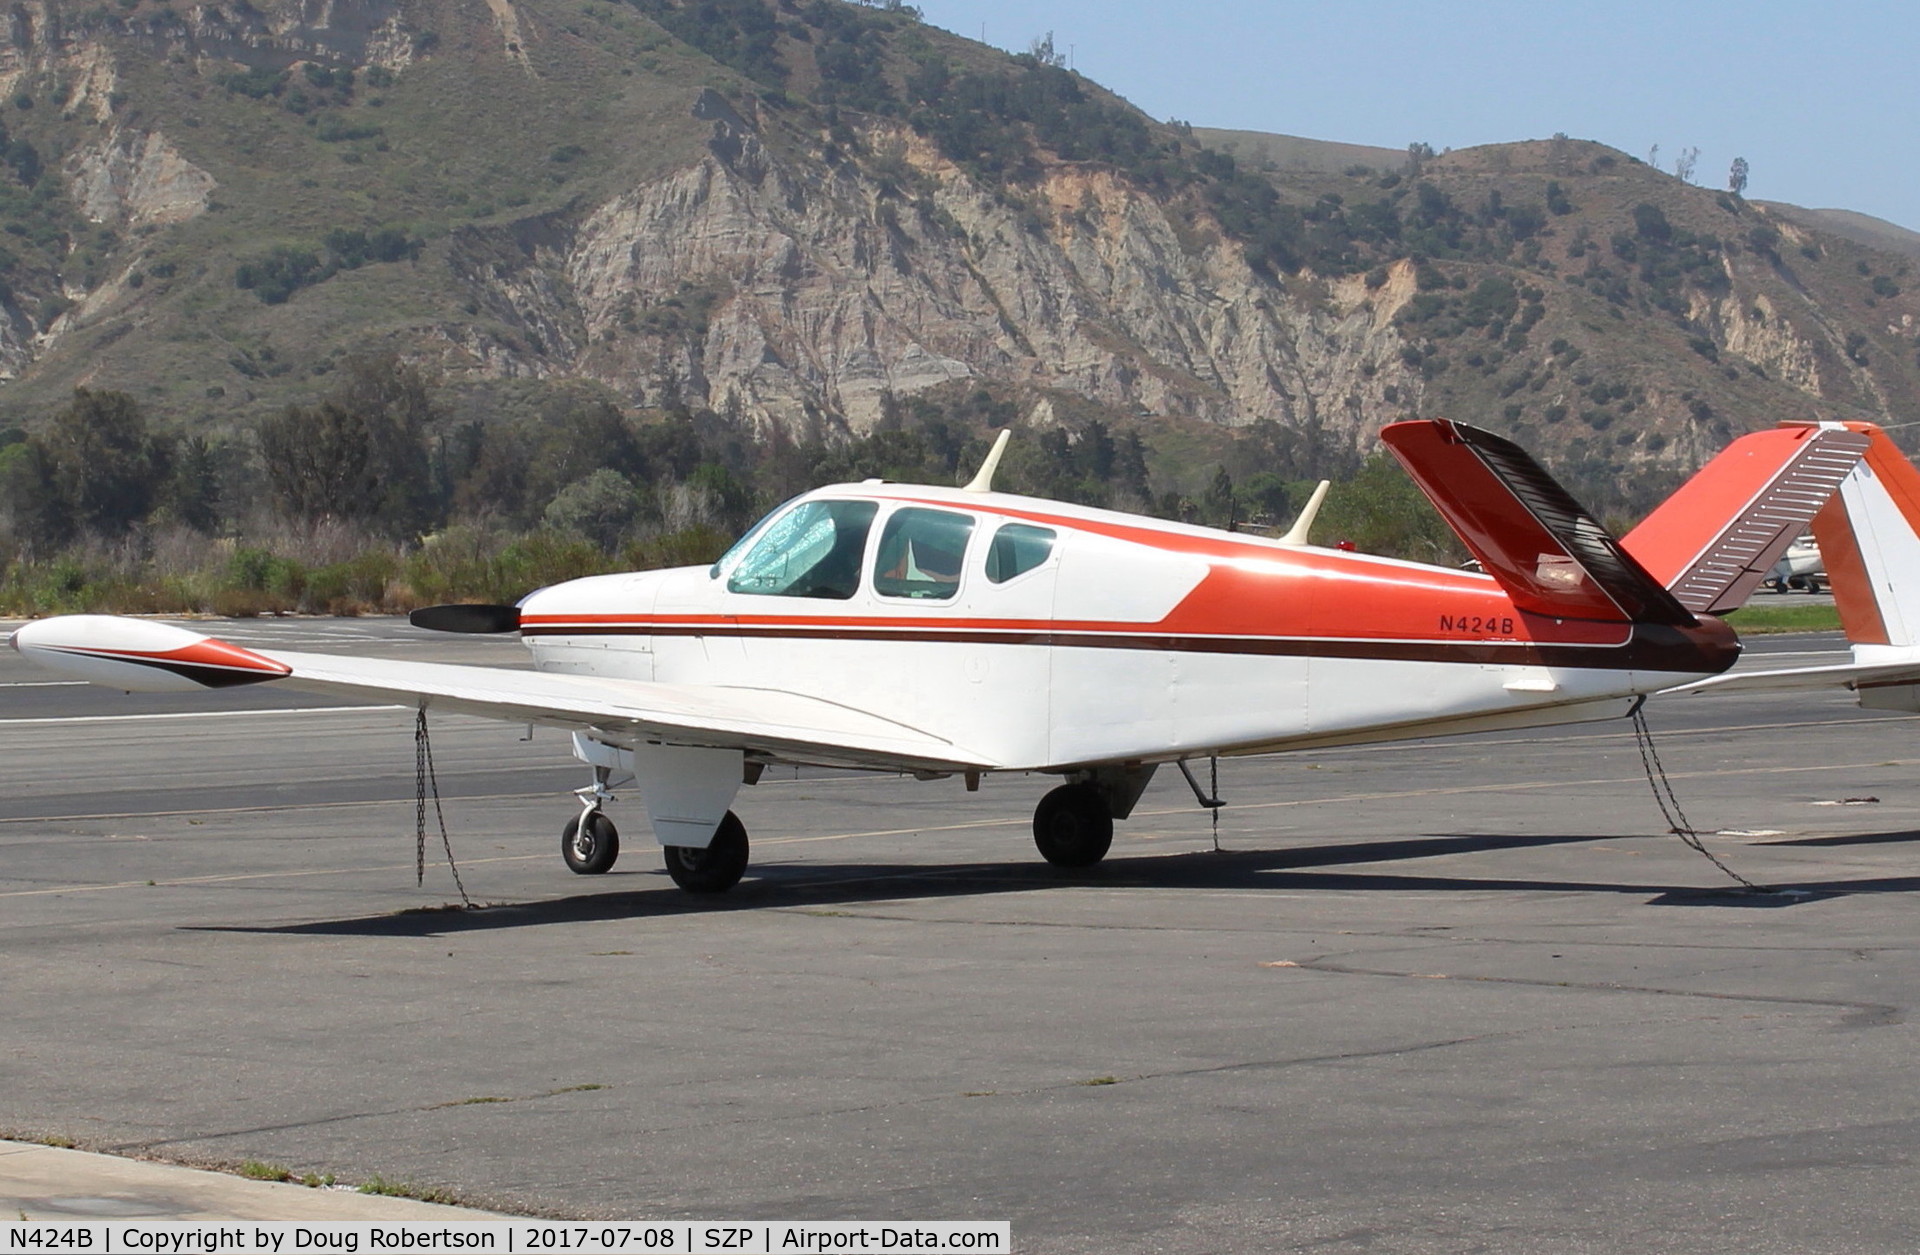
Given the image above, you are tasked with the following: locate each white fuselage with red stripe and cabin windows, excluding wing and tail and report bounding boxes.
[520,484,1740,770]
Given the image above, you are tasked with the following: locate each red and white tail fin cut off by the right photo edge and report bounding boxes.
[1812,422,1920,654]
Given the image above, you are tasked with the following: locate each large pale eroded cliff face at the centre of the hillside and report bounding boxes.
[447,94,1419,445]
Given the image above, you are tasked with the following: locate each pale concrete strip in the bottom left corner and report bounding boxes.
[0,1142,515,1220]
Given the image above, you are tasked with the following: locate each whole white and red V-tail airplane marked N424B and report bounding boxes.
[13,420,1868,892]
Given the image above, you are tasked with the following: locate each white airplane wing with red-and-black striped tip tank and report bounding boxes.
[0,614,998,771]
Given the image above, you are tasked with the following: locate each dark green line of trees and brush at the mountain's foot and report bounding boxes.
[0,355,1482,614]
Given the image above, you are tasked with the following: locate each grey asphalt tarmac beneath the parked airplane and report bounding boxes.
[0,620,1920,1253]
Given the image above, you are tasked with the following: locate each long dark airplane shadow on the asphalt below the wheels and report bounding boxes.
[190,833,1920,936]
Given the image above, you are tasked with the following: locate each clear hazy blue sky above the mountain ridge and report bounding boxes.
[918,0,1920,230]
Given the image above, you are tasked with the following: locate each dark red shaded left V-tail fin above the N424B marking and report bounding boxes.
[1380,418,1695,626]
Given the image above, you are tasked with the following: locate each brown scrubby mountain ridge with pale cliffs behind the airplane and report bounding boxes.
[0,0,1920,514]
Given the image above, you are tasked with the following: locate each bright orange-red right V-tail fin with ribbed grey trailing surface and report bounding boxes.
[1620,422,1873,614]
